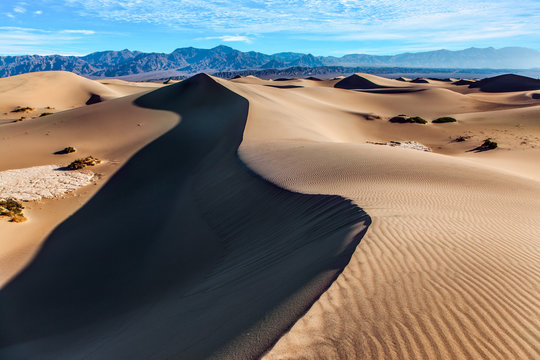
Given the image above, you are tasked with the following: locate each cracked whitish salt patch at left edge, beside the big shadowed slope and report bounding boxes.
[0,165,94,201]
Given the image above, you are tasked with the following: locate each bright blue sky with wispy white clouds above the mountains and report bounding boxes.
[0,0,540,56]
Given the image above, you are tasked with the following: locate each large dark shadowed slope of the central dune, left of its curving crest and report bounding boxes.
[0,75,370,359]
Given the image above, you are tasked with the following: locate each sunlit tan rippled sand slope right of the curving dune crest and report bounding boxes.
[225,75,540,359]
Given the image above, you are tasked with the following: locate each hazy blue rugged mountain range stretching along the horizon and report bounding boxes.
[0,45,540,77]
